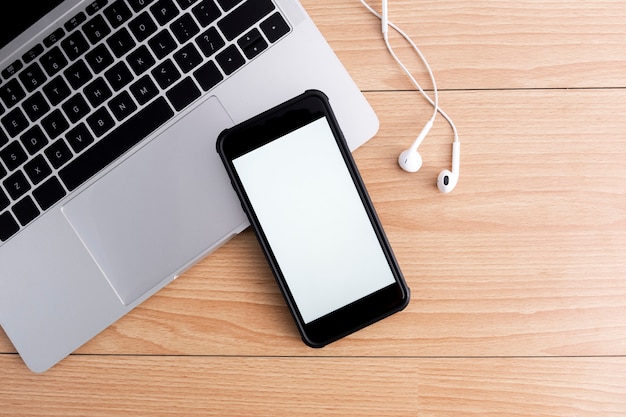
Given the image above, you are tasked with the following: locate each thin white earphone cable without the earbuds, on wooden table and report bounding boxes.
[360,0,459,142]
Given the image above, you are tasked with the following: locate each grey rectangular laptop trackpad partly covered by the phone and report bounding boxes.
[63,97,245,305]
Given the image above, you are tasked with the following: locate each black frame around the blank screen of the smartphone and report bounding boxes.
[217,90,409,347]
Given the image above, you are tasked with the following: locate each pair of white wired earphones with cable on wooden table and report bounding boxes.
[361,0,461,193]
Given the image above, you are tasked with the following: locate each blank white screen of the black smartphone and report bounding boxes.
[233,117,395,323]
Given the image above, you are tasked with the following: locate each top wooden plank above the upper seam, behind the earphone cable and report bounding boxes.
[303,0,626,90]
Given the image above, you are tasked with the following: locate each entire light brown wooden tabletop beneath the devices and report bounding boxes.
[0,0,626,417]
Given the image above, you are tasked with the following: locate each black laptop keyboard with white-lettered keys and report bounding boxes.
[0,0,290,242]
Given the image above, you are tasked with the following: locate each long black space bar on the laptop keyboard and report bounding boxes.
[59,97,174,191]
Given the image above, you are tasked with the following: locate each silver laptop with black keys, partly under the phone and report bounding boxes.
[0,0,378,372]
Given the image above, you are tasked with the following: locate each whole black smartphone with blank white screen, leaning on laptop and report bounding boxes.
[217,90,409,347]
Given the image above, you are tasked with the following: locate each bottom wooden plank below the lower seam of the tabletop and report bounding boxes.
[0,356,626,417]
